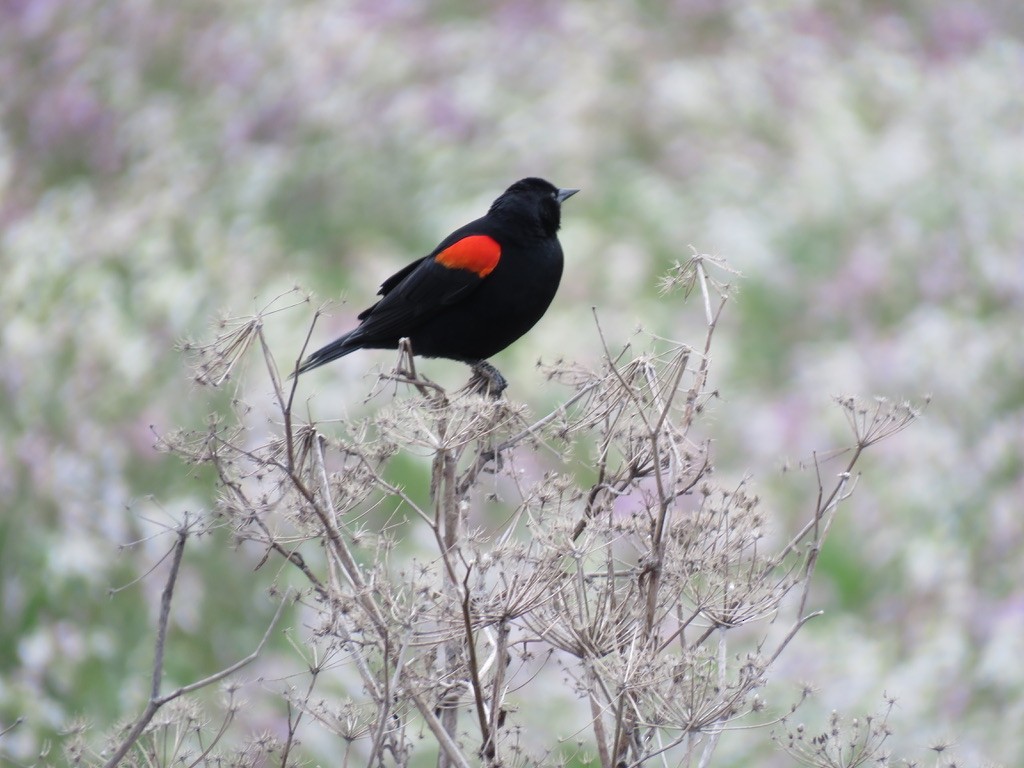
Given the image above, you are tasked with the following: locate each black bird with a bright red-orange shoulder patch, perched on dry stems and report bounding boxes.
[295,178,579,394]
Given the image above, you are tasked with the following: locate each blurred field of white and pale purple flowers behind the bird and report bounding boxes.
[0,0,1024,766]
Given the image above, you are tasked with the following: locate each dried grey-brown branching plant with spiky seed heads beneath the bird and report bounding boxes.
[90,260,914,768]
